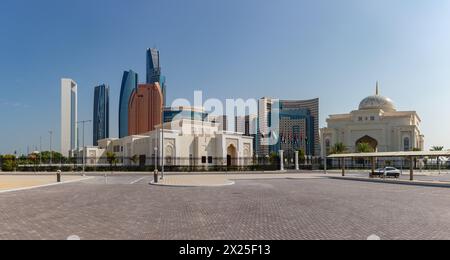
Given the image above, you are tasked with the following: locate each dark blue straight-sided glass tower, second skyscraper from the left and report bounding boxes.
[92,85,109,146]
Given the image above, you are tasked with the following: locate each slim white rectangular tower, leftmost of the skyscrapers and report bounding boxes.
[61,79,78,157]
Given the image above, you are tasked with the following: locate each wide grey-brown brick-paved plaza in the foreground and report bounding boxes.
[0,173,450,240]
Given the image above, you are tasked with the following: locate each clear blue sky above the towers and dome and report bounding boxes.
[0,0,450,153]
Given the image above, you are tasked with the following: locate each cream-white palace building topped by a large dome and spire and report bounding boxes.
[321,83,424,155]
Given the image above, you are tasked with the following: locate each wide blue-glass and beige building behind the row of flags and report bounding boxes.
[256,98,320,158]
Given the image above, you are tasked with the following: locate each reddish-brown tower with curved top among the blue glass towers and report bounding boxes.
[128,82,163,135]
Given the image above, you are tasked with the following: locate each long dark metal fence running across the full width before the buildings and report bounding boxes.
[0,156,450,172]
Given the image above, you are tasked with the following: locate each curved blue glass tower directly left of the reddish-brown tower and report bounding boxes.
[119,70,138,138]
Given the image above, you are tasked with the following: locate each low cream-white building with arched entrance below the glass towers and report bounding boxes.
[81,119,253,168]
